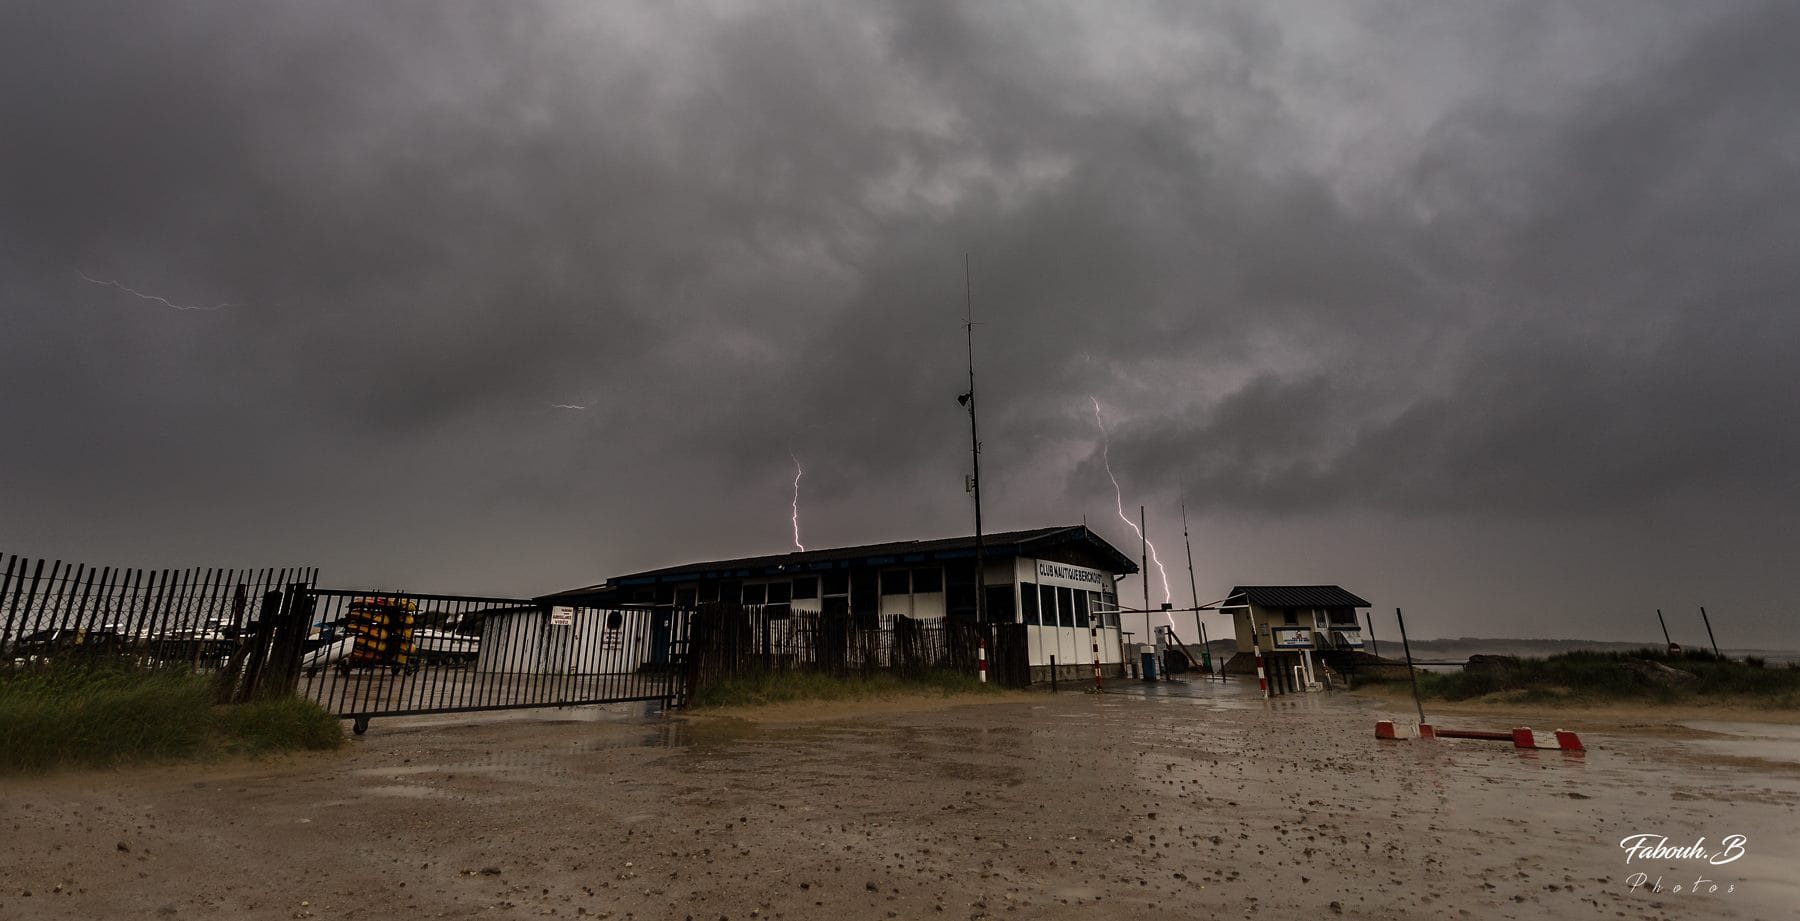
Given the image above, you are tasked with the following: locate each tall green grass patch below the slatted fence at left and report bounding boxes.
[0,666,344,773]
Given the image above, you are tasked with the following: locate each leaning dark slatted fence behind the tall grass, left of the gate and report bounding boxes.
[0,554,319,683]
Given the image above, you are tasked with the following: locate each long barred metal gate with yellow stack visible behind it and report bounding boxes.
[286,586,693,736]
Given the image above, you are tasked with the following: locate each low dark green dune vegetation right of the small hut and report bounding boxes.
[1418,649,1800,709]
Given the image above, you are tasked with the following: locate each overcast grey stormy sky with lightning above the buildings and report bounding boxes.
[0,0,1800,648]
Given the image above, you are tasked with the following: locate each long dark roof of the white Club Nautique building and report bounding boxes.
[538,525,1138,604]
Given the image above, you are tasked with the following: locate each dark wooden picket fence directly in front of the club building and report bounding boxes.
[688,604,1031,694]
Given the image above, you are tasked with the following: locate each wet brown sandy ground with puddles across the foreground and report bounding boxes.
[0,684,1800,921]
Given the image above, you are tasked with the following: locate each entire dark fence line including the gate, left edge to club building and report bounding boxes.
[0,554,1030,734]
